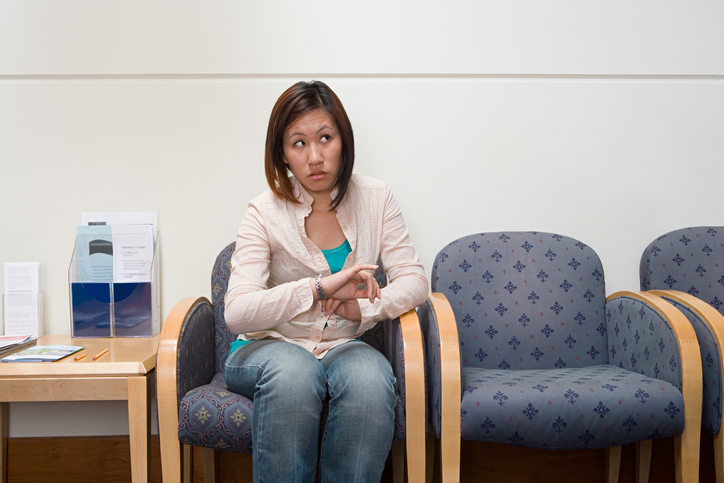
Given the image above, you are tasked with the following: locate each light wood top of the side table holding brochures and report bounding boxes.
[0,335,159,378]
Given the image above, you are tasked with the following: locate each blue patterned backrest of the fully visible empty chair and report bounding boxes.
[431,232,608,369]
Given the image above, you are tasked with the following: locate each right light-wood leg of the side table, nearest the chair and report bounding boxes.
[128,375,151,483]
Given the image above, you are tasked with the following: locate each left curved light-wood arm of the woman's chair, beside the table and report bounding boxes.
[156,297,211,483]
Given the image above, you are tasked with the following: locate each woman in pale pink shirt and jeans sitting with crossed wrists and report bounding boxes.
[224,82,428,483]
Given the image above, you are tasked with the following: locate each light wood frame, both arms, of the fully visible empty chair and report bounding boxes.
[428,291,702,483]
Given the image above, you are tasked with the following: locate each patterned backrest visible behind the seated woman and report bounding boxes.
[211,242,387,372]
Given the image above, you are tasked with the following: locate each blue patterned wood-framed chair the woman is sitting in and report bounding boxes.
[156,243,426,483]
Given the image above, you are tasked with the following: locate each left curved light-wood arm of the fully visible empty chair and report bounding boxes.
[427,292,462,483]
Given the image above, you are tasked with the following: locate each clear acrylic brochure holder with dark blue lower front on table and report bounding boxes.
[68,236,161,337]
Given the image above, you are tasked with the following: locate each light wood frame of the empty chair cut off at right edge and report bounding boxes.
[648,290,724,483]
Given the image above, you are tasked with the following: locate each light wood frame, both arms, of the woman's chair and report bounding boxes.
[156,297,426,483]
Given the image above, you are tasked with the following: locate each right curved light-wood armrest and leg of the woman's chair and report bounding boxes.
[400,309,426,482]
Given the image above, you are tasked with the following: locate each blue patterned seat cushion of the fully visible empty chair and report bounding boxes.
[461,365,684,449]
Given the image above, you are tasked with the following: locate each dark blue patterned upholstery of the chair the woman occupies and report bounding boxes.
[177,246,405,454]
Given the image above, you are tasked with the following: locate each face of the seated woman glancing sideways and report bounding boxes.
[282,109,342,201]
